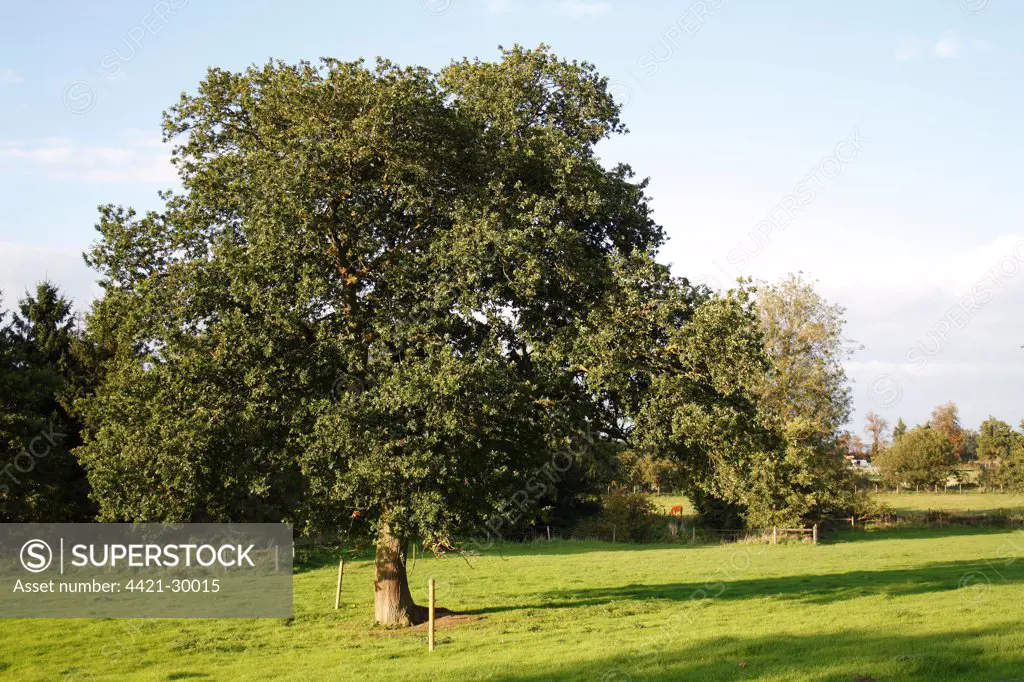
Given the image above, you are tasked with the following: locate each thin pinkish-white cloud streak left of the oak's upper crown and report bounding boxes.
[0,130,178,184]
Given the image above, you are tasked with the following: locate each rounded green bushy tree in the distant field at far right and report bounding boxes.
[876,426,957,486]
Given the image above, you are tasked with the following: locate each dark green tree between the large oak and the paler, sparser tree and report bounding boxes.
[580,272,781,527]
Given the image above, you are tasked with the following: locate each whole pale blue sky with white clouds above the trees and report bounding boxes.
[0,0,1024,430]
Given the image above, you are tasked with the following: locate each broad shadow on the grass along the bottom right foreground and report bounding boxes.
[488,624,1024,682]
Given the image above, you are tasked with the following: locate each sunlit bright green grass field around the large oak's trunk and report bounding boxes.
[6,528,1024,682]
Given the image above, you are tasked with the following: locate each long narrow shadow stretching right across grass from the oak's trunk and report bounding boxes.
[462,559,1024,613]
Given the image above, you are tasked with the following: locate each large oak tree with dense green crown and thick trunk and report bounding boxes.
[80,46,663,624]
